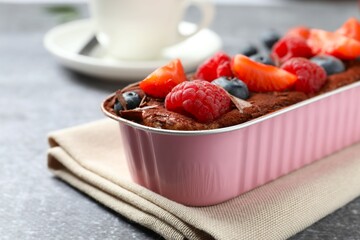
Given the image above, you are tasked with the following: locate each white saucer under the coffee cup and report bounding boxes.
[44,19,222,81]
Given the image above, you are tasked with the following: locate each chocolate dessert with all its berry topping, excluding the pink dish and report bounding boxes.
[105,18,360,130]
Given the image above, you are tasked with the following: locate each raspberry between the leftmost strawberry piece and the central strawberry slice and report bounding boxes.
[195,52,233,82]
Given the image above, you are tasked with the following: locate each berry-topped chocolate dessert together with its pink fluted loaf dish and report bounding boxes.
[102,19,360,206]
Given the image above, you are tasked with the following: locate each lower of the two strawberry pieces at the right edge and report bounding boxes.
[307,29,360,60]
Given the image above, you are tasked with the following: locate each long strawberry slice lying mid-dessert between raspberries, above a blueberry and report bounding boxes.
[231,54,297,92]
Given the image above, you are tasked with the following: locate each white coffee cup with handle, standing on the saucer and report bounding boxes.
[89,0,214,60]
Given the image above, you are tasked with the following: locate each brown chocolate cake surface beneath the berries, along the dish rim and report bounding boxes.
[105,61,360,130]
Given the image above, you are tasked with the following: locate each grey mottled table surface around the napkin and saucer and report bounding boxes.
[0,1,360,240]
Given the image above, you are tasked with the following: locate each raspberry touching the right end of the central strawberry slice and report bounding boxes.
[281,58,327,93]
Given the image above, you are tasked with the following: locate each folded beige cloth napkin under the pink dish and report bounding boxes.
[48,119,360,240]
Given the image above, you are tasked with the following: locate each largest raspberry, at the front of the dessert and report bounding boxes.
[165,80,231,123]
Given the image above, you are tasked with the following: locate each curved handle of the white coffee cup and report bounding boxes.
[177,0,215,42]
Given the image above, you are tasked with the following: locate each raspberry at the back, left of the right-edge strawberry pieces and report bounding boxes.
[271,36,313,65]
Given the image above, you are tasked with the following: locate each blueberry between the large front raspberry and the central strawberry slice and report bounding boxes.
[211,77,250,99]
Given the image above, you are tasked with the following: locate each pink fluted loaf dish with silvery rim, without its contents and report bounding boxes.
[102,82,360,206]
